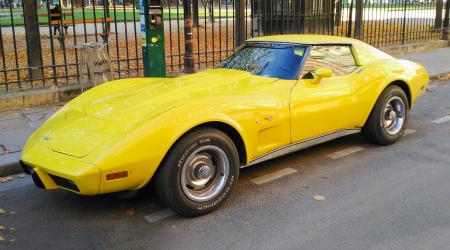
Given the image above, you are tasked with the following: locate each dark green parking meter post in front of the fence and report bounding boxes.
[139,0,166,77]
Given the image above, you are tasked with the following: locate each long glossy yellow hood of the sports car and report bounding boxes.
[39,69,278,158]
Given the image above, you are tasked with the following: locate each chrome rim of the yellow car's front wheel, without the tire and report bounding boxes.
[181,145,230,202]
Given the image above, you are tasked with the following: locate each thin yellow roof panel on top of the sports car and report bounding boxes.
[247,35,361,44]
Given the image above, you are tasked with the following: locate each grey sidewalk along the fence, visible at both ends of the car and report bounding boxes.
[0,47,450,176]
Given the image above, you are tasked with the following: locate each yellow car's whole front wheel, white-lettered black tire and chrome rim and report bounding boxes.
[156,128,239,217]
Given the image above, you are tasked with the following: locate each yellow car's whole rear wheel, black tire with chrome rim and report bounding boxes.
[363,85,409,145]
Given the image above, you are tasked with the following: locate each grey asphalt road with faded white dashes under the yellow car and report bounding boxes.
[0,81,450,249]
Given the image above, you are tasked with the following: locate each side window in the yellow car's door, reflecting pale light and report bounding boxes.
[301,45,357,79]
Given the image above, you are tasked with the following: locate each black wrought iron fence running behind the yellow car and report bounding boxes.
[0,0,450,93]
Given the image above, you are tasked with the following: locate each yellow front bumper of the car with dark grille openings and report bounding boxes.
[21,144,101,195]
